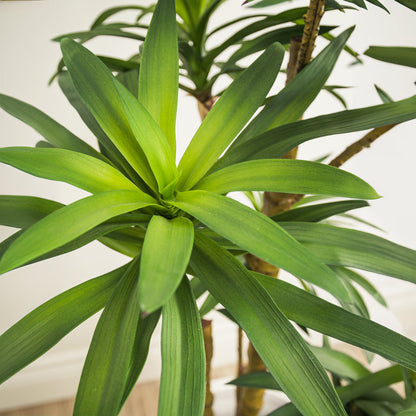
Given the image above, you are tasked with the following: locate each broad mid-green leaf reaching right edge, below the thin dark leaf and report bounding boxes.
[280,222,416,283]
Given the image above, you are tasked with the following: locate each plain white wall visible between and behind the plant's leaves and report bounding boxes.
[0,0,416,409]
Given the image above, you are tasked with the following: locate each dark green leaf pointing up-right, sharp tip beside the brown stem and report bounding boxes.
[224,28,353,148]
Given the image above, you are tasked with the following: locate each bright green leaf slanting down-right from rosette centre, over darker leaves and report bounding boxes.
[173,191,348,300]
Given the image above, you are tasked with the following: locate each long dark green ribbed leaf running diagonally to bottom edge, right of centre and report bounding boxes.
[191,234,346,416]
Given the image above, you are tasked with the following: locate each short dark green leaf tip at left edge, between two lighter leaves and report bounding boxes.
[0,195,63,228]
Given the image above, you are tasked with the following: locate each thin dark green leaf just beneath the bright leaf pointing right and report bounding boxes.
[271,200,369,222]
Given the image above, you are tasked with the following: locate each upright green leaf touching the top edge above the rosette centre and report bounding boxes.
[139,0,179,155]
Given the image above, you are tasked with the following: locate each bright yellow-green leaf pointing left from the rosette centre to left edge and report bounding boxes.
[0,147,138,193]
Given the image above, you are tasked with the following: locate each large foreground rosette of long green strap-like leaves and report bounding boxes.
[0,0,416,416]
